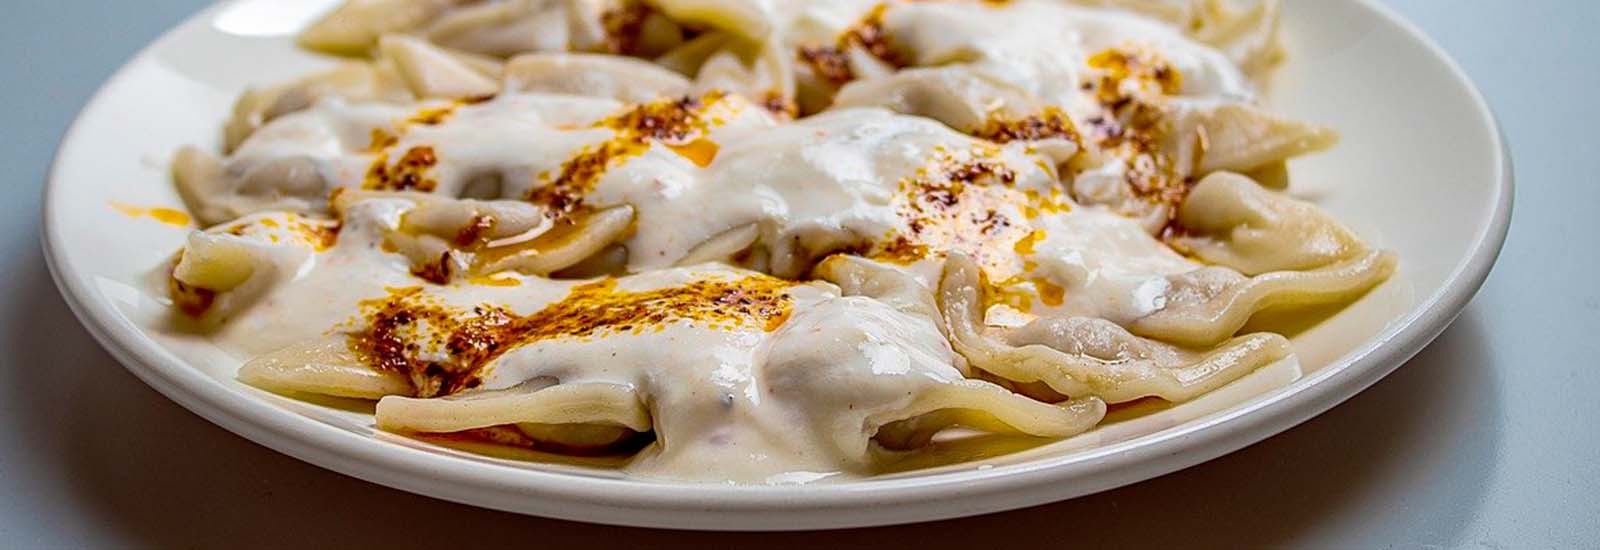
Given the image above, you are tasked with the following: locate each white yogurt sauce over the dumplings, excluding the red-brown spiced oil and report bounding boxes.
[165,2,1286,483]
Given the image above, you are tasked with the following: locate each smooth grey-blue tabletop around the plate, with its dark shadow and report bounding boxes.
[0,0,1600,548]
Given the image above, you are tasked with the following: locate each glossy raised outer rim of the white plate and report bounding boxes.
[42,0,1514,529]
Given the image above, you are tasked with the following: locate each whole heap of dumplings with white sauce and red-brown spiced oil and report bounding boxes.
[163,0,1395,483]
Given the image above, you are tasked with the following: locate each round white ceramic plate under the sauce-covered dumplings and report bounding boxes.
[45,0,1512,529]
